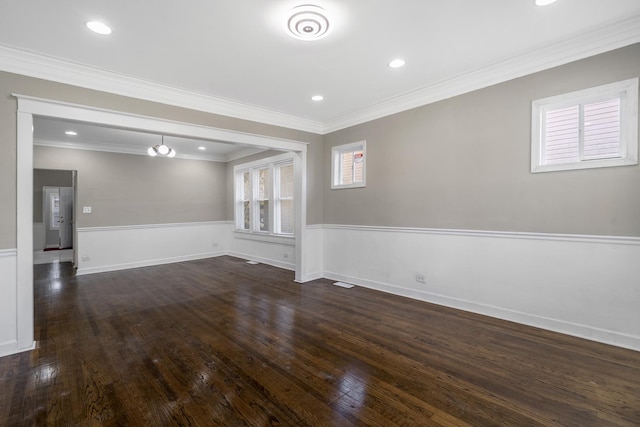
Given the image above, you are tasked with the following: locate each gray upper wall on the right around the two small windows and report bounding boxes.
[323,44,640,236]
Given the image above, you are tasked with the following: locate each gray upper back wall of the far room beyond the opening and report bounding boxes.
[33,146,227,227]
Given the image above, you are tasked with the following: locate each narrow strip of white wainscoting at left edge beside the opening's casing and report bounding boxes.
[0,249,19,356]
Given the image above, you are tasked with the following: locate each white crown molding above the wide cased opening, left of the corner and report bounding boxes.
[0,45,322,133]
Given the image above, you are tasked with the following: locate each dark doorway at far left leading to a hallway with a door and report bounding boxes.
[33,169,76,264]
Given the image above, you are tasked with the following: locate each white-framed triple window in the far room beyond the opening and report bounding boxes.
[234,154,294,235]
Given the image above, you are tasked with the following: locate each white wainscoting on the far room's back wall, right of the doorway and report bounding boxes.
[77,221,229,275]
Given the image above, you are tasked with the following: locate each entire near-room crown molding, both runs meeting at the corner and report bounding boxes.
[0,15,640,134]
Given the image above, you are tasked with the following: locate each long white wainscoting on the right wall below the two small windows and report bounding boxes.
[323,225,640,350]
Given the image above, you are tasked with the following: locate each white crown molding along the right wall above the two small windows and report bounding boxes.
[323,15,640,134]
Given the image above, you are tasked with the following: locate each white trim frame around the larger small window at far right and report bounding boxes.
[531,77,638,173]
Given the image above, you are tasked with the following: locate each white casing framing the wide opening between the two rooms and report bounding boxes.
[12,93,308,351]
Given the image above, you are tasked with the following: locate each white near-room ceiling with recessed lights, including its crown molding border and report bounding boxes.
[0,0,640,160]
